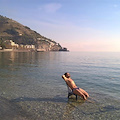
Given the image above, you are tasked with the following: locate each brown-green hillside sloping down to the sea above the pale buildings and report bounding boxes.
[0,15,66,51]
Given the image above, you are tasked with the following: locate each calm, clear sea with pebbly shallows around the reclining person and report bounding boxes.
[0,52,120,120]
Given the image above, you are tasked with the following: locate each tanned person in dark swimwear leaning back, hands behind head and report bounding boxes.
[62,73,89,100]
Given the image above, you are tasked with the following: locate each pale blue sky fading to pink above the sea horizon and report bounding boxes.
[0,0,120,52]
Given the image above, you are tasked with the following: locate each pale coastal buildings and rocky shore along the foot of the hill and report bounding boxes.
[0,38,68,52]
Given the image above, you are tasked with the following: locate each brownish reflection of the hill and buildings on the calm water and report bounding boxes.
[0,52,59,67]
